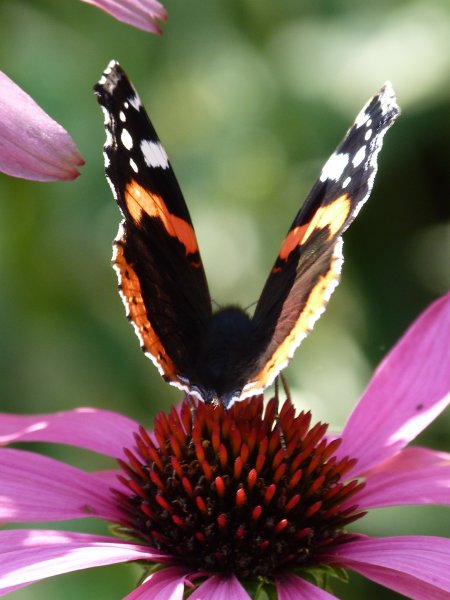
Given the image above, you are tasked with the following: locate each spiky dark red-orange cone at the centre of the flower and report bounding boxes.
[117,397,362,579]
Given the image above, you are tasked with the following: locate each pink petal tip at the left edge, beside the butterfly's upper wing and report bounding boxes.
[0,71,84,181]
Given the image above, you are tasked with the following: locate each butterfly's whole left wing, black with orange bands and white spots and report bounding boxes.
[94,61,212,391]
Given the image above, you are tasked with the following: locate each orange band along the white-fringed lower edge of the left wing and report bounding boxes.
[113,241,177,381]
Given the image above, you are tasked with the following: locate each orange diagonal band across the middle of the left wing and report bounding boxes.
[125,181,198,254]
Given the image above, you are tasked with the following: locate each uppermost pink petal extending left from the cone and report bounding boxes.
[0,408,139,458]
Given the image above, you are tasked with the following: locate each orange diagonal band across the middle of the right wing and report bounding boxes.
[279,194,351,260]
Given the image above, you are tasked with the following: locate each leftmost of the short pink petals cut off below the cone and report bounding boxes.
[124,567,188,600]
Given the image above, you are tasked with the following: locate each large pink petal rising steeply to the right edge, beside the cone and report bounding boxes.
[337,294,450,477]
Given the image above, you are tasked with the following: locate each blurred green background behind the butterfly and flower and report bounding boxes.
[0,0,450,600]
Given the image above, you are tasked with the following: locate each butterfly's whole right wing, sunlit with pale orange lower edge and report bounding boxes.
[241,83,399,398]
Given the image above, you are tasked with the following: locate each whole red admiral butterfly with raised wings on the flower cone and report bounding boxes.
[94,61,399,407]
